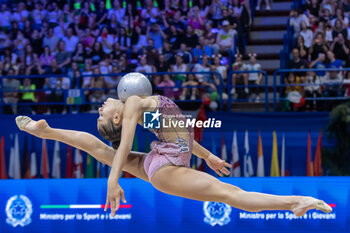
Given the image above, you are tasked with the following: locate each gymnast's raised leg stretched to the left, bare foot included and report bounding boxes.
[16,116,148,181]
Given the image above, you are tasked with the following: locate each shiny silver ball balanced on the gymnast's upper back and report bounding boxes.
[118,72,152,103]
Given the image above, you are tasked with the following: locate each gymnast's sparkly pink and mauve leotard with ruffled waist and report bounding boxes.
[144,95,194,180]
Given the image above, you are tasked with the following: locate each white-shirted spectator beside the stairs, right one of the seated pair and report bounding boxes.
[245,53,262,102]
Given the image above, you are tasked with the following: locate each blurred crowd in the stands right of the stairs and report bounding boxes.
[284,0,350,111]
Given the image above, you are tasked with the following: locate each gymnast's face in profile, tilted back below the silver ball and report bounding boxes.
[97,98,124,128]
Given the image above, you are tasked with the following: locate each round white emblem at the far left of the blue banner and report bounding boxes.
[5,195,33,227]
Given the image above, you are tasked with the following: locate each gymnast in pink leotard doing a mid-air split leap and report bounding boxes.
[16,95,332,217]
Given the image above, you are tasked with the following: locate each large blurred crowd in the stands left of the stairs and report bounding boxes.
[0,0,253,114]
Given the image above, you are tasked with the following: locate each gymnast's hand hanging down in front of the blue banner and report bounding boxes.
[105,180,126,217]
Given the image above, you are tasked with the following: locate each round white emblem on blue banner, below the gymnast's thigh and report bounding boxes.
[203,201,232,226]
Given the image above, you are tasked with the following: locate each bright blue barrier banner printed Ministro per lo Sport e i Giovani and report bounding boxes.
[0,177,350,233]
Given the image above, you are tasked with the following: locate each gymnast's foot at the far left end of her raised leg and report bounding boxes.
[16,116,50,138]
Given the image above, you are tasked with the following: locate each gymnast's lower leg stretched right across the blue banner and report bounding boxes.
[151,166,332,216]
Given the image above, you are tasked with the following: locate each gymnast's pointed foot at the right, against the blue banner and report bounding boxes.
[292,197,332,217]
